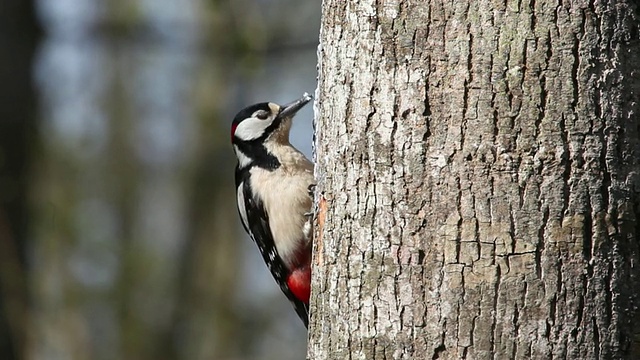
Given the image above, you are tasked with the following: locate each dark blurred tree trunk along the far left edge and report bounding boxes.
[0,0,40,360]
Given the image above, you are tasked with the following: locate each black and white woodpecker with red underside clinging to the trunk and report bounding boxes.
[231,93,315,327]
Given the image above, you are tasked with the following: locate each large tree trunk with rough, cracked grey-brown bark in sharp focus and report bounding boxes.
[308,0,640,360]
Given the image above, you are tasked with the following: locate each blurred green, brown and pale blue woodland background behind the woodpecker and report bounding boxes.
[0,0,320,360]
